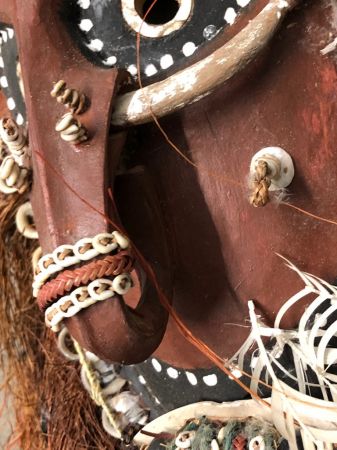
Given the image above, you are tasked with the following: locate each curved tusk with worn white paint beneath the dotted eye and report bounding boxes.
[111,0,299,126]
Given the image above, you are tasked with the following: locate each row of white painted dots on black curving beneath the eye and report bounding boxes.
[77,0,251,77]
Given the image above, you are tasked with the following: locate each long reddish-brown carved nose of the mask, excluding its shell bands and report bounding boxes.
[14,0,167,363]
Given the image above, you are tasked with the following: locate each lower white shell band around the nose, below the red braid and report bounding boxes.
[45,273,132,332]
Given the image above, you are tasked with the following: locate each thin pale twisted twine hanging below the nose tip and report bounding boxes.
[73,340,122,439]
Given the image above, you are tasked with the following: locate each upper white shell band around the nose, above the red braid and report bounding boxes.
[33,231,130,297]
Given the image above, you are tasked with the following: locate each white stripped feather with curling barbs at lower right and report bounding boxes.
[235,257,337,450]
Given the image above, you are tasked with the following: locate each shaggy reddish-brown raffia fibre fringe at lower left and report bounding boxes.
[0,194,118,450]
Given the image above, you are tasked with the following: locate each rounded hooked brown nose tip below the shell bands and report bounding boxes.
[66,283,167,364]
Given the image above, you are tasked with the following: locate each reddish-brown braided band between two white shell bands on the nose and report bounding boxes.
[37,250,134,311]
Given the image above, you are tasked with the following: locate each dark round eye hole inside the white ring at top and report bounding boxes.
[135,0,180,25]
